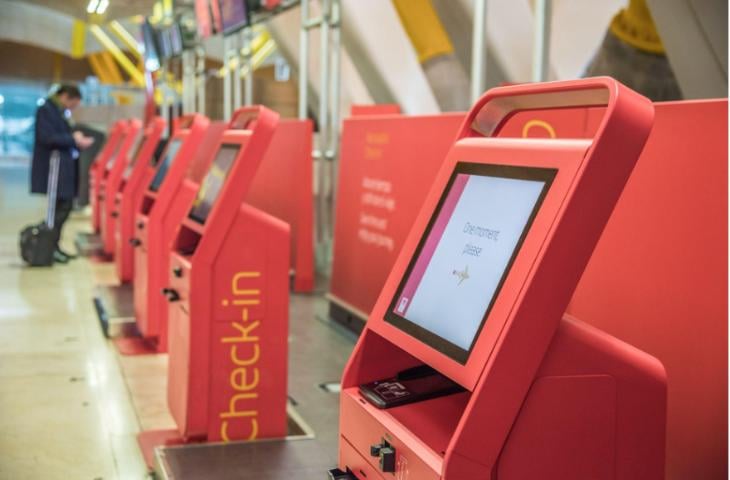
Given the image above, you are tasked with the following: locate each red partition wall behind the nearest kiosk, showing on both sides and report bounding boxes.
[331,99,728,480]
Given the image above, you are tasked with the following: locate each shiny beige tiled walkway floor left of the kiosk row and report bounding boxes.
[0,164,149,480]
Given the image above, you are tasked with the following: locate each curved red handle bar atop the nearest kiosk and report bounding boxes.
[457,77,654,148]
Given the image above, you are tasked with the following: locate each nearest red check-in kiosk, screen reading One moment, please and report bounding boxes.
[329,78,666,480]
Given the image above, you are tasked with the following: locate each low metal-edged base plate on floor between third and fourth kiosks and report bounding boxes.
[94,285,139,338]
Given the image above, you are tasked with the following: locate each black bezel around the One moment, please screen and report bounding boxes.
[384,162,558,365]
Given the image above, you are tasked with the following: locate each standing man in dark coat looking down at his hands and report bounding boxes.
[30,85,94,263]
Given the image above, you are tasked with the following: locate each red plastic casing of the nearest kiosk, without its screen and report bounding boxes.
[340,78,666,480]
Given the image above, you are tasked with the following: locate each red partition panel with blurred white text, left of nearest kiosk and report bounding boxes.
[330,114,464,317]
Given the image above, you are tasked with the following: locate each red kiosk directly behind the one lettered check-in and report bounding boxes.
[132,114,210,351]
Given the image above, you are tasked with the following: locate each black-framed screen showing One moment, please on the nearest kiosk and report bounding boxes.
[385,163,556,363]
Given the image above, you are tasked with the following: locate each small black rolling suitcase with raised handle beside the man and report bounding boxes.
[20,151,61,267]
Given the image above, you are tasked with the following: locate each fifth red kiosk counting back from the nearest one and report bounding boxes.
[100,119,142,255]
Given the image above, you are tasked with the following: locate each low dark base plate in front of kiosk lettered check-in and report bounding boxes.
[143,404,312,472]
